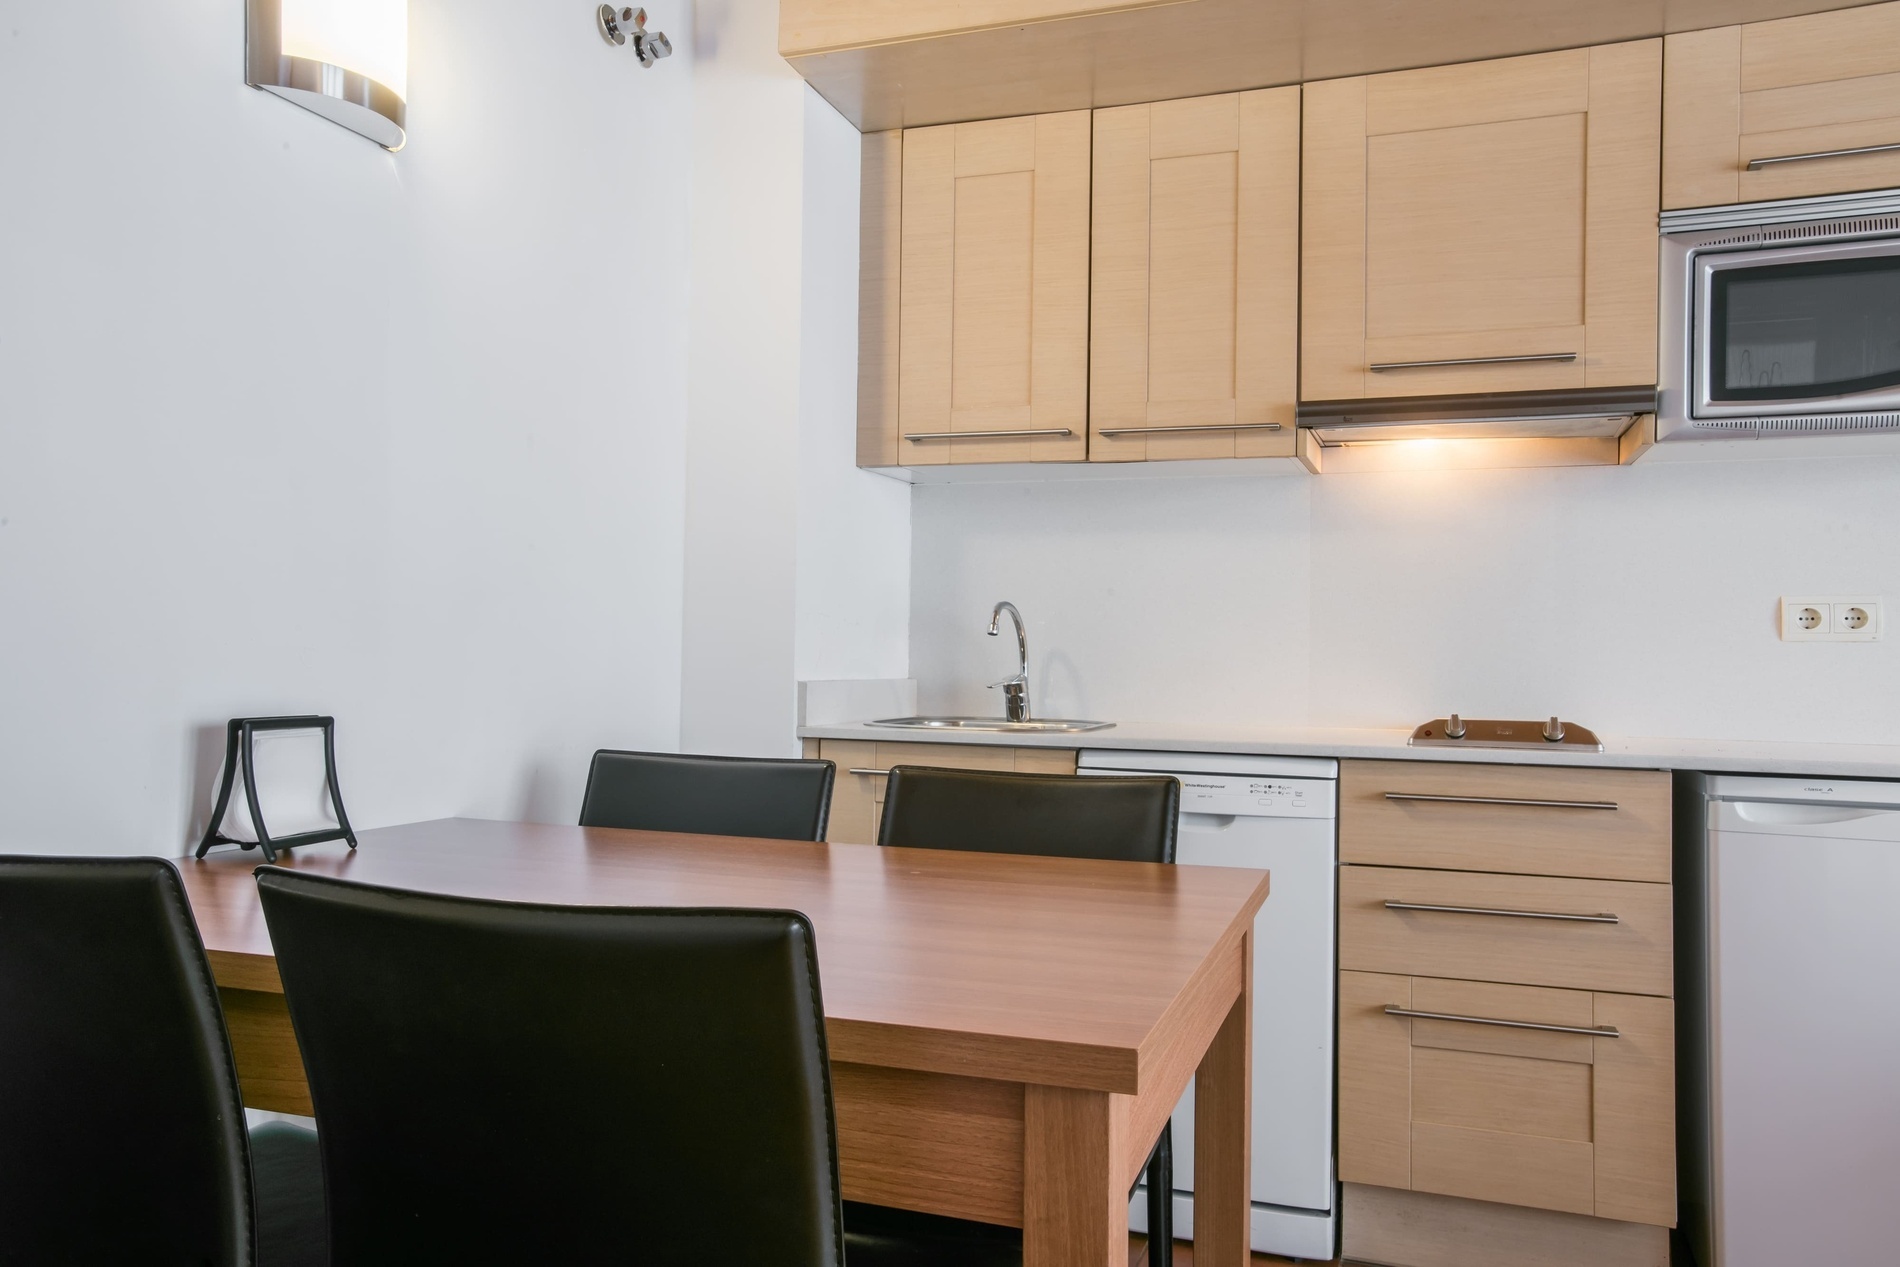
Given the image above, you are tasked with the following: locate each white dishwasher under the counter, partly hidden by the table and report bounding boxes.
[1075,750,1340,1259]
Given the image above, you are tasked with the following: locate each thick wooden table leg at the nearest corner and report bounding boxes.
[1022,1087,1129,1267]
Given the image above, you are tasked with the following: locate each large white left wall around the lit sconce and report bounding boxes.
[0,0,699,853]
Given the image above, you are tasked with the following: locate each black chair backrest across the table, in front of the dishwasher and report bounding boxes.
[878,766,1180,862]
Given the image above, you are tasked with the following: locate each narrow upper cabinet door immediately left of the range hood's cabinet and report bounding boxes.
[1089,87,1300,462]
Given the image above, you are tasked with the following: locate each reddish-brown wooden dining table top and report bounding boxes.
[179,819,1267,1094]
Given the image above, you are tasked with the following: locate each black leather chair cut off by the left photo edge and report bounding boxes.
[0,857,329,1267]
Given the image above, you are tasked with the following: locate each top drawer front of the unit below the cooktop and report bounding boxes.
[1340,762,1672,883]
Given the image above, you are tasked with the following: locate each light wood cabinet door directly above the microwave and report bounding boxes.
[1663,4,1900,209]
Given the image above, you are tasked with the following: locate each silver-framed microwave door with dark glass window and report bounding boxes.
[1695,239,1900,418]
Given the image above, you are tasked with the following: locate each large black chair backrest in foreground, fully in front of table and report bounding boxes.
[258,866,844,1267]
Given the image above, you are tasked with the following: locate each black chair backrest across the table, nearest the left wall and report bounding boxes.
[581,748,838,840]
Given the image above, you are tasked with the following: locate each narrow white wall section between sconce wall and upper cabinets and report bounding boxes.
[680,0,910,756]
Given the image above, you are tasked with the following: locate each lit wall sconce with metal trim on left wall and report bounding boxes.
[245,0,409,150]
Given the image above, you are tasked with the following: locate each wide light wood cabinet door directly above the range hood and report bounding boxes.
[1300,40,1663,401]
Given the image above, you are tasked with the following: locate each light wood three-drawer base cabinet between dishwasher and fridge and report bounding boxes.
[1340,762,1676,1267]
